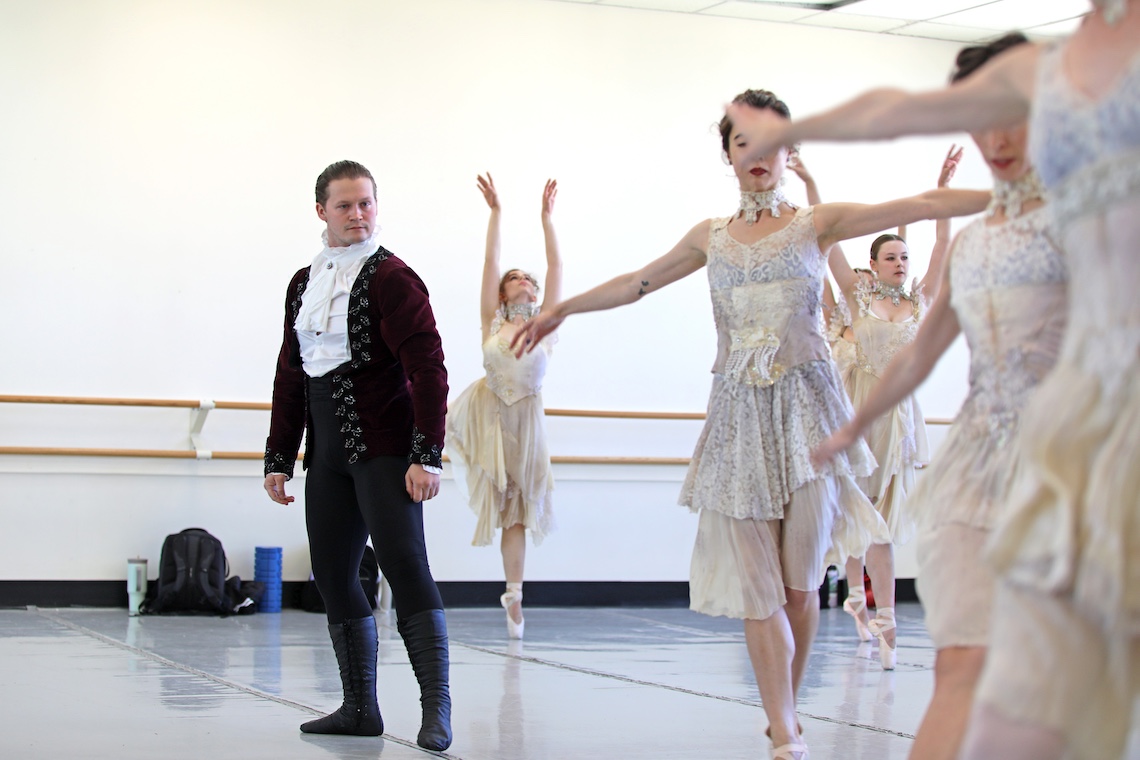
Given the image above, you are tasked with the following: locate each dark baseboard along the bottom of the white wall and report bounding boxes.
[0,578,918,608]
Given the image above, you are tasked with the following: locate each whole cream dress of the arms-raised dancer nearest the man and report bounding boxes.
[446,313,554,546]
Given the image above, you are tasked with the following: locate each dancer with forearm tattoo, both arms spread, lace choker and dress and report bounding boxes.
[515,90,990,760]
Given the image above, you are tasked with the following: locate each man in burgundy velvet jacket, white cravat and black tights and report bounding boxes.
[264,161,451,751]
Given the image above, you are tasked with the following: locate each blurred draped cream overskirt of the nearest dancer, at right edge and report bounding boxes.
[990,327,1140,636]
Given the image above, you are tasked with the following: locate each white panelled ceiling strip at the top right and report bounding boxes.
[538,0,1090,42]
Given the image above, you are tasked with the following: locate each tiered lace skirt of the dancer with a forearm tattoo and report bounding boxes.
[679,361,889,620]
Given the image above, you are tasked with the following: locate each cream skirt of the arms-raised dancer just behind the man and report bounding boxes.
[447,378,555,546]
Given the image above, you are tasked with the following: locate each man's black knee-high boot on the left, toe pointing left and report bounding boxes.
[301,616,384,736]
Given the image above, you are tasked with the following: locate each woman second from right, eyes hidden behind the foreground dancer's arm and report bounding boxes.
[819,33,1067,760]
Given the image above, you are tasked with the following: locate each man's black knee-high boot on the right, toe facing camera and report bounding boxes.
[396,610,451,751]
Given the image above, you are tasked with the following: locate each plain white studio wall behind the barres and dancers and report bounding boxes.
[0,0,988,580]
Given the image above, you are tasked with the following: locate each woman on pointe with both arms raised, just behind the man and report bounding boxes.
[447,173,562,639]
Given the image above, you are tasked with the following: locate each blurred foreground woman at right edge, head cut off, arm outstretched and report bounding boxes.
[732,0,1140,760]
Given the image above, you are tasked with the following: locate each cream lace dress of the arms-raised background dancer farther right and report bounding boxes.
[845,279,930,545]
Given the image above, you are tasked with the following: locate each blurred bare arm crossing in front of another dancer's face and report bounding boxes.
[727,44,1039,162]
